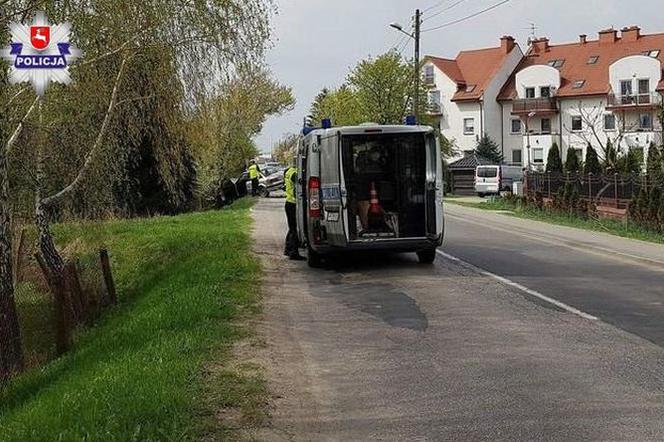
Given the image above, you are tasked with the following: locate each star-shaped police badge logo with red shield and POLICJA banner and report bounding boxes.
[0,12,82,96]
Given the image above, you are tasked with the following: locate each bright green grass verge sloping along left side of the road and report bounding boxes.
[0,201,267,441]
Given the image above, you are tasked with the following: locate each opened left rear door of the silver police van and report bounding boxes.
[320,132,348,247]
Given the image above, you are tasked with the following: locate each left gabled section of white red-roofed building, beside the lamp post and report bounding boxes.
[423,36,523,161]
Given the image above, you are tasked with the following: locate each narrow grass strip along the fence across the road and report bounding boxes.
[449,198,664,244]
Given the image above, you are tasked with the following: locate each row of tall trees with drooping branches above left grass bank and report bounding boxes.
[0,0,294,382]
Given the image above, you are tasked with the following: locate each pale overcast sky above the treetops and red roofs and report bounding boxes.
[256,0,664,152]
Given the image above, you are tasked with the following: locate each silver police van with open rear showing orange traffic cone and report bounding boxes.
[297,124,443,267]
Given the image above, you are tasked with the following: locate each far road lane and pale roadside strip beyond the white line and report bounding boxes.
[443,204,664,346]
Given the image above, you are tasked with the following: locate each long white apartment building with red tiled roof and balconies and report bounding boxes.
[424,26,664,173]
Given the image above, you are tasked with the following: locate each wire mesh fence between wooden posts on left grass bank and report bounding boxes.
[0,227,117,378]
